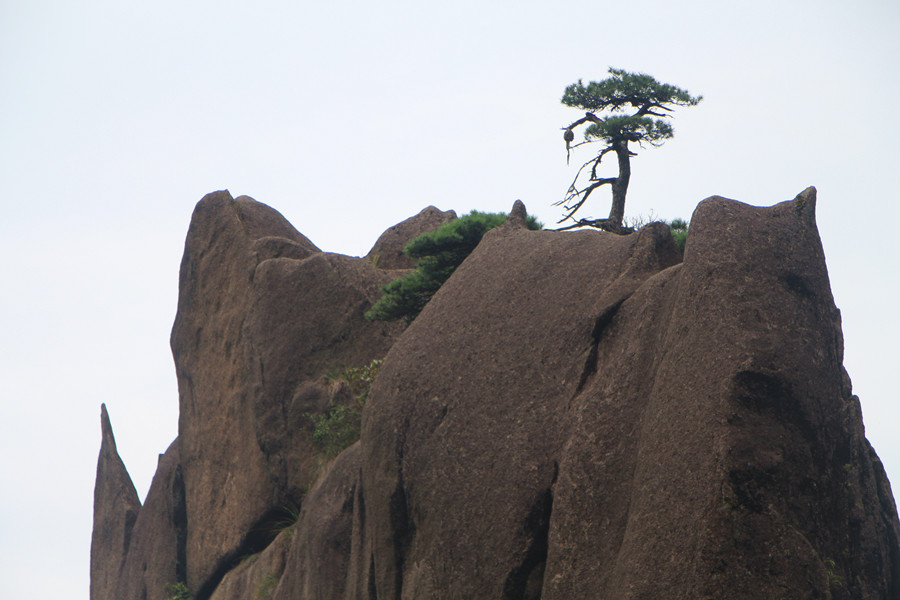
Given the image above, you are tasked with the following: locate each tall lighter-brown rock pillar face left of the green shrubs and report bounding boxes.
[172,192,304,593]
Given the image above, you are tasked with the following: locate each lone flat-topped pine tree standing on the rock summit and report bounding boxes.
[554,67,703,233]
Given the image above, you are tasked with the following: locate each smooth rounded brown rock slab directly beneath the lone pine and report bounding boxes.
[362,212,679,598]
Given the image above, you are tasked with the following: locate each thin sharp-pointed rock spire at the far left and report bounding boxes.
[90,404,141,600]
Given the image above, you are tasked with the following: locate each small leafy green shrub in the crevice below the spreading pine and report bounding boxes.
[310,359,383,459]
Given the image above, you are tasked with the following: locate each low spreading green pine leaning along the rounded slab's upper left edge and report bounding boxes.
[366,210,543,323]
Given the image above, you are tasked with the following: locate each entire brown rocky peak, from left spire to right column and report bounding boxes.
[92,188,900,600]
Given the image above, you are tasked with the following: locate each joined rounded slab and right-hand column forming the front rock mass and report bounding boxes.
[358,195,900,600]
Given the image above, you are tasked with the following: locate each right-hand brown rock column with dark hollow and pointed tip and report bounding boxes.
[542,192,900,599]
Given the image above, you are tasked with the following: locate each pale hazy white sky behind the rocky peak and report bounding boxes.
[0,0,900,600]
